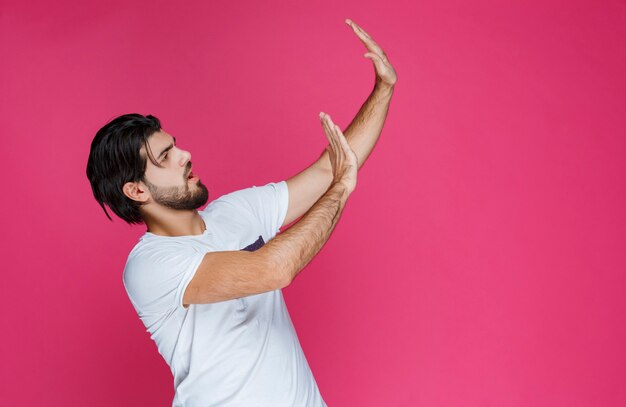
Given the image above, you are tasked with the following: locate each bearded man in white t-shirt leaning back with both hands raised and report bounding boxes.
[87,20,397,407]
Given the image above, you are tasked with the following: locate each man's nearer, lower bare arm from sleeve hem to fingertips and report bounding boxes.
[183,112,357,307]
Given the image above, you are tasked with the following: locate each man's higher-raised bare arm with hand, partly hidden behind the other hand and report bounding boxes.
[281,19,397,227]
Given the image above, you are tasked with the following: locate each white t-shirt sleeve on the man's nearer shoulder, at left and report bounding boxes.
[123,242,204,316]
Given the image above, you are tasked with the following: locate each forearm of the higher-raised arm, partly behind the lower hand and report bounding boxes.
[318,82,394,171]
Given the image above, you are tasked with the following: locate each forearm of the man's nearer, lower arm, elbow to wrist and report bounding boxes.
[259,183,348,286]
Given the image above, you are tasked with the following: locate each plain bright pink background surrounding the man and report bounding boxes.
[0,0,626,407]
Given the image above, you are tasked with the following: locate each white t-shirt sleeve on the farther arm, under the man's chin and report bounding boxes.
[214,181,289,242]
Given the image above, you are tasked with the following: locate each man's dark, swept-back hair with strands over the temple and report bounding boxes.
[87,113,166,224]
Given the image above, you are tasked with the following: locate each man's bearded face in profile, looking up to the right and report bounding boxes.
[142,129,209,210]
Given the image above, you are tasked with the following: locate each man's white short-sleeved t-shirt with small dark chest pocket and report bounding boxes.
[123,181,326,407]
